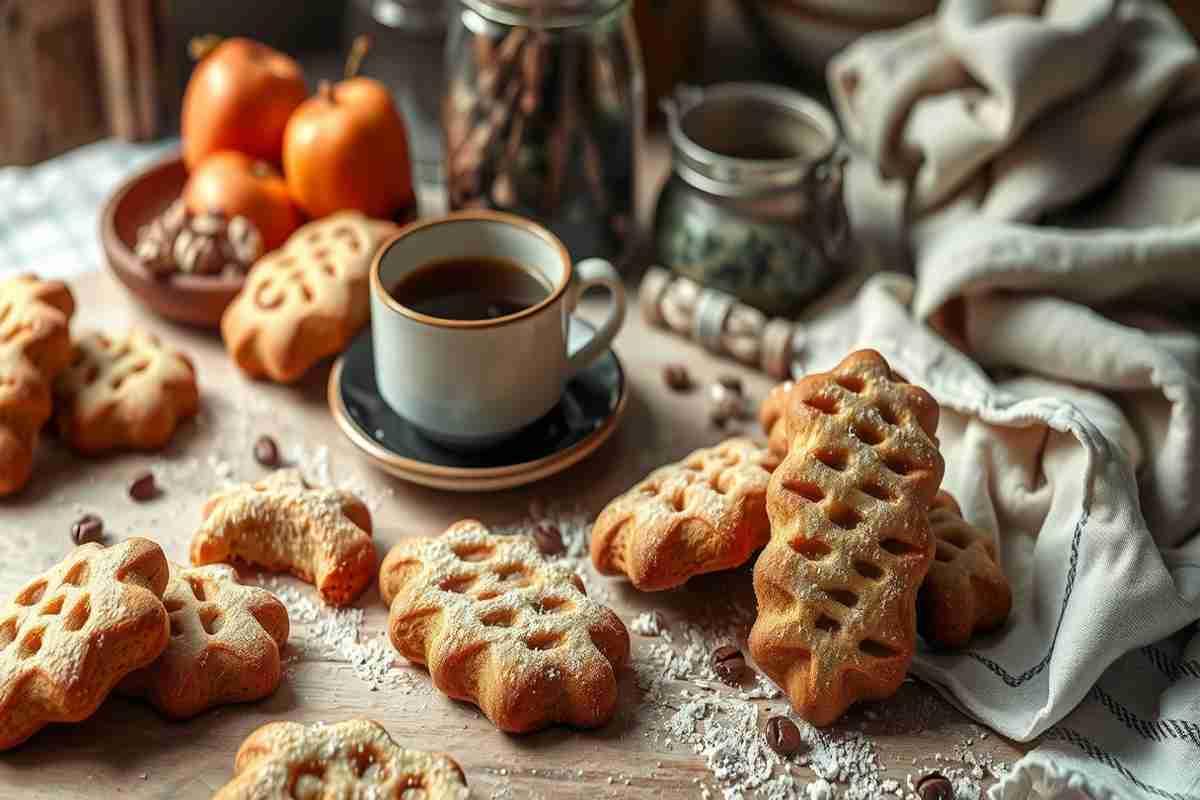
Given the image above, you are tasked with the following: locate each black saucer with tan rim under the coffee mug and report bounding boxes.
[328,317,629,492]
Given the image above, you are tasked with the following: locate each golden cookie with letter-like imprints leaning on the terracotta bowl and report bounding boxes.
[221,211,378,383]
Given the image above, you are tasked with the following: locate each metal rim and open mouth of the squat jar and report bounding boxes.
[664,83,838,197]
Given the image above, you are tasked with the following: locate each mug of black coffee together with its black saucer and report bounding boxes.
[329,211,628,492]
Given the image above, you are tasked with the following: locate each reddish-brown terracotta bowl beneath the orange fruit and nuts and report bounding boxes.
[100,156,245,327]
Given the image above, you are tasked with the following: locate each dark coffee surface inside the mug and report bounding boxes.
[389,257,550,320]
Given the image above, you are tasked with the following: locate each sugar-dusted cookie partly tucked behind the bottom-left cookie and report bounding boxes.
[118,564,288,718]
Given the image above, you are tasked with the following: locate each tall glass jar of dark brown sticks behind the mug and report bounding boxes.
[442,0,644,264]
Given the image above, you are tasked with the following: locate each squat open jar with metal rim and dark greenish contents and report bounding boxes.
[654,83,850,314]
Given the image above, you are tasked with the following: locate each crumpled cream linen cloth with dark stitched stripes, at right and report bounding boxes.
[820,0,1200,800]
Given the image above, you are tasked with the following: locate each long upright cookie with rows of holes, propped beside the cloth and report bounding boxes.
[749,350,943,726]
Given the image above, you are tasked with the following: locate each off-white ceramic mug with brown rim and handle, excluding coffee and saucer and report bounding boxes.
[371,211,625,449]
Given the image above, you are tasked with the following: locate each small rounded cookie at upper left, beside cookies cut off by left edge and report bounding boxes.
[55,330,200,455]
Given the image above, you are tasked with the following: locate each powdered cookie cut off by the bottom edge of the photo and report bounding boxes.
[212,720,469,800]
